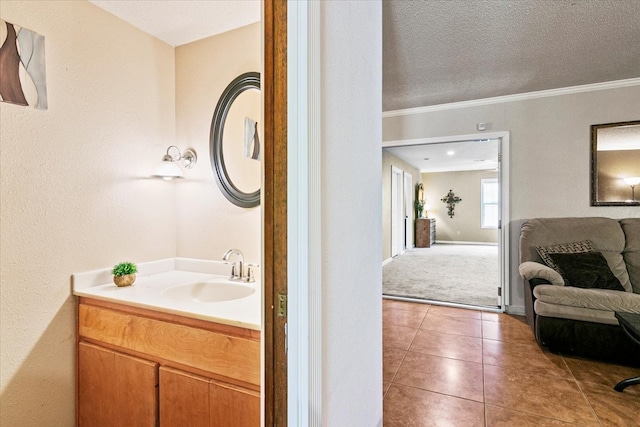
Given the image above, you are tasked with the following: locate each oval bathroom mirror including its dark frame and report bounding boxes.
[209,72,262,208]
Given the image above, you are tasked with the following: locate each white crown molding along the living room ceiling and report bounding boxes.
[382,78,640,118]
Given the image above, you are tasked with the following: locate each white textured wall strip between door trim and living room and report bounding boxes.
[321,1,382,426]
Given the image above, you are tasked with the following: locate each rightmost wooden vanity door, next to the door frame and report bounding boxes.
[209,381,260,427]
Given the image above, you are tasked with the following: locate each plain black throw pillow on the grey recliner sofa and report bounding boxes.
[549,252,624,291]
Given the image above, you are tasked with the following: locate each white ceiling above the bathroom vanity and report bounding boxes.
[89,0,261,46]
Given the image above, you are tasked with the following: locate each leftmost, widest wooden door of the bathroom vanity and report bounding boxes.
[78,342,158,427]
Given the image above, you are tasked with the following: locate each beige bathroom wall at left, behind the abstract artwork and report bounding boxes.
[0,0,176,427]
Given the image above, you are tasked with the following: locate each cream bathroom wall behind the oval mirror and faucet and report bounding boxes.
[176,23,262,263]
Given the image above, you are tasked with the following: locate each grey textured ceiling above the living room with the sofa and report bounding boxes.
[382,0,640,111]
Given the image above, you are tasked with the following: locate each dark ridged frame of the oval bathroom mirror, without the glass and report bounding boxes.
[209,72,260,208]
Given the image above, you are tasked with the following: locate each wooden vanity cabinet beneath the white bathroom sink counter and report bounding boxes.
[77,298,260,427]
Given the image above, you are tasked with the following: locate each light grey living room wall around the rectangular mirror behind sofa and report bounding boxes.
[382,85,640,307]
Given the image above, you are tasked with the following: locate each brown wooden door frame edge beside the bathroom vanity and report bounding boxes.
[262,0,287,427]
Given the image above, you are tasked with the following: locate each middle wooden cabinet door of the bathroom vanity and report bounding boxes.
[160,367,211,427]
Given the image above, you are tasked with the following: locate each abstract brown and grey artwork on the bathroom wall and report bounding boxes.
[0,20,47,110]
